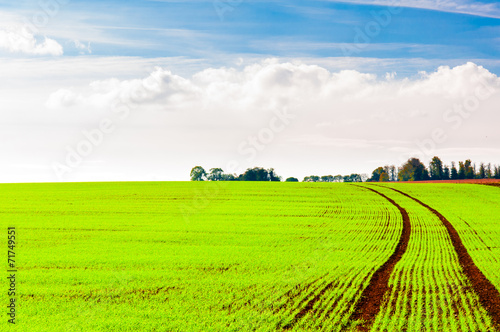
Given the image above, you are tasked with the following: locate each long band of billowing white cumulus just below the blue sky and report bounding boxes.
[47,59,500,114]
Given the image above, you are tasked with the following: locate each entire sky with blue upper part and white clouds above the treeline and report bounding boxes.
[0,0,500,182]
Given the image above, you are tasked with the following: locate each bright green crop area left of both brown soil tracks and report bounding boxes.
[0,183,400,331]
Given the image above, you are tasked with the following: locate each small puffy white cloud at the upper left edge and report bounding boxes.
[0,26,63,56]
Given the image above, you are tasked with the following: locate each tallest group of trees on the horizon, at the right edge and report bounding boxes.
[368,157,500,182]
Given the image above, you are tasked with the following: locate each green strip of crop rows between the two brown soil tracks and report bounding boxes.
[372,187,492,331]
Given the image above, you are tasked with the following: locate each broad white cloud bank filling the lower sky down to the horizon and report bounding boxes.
[0,57,500,181]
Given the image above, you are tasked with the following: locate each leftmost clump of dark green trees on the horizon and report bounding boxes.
[190,166,281,181]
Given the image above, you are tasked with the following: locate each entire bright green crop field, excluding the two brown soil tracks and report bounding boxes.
[0,182,500,331]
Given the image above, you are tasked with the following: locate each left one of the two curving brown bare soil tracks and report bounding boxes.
[351,187,411,331]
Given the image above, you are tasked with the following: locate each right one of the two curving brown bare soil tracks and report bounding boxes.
[390,188,500,331]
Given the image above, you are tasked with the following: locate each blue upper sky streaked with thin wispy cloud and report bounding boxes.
[2,0,500,66]
